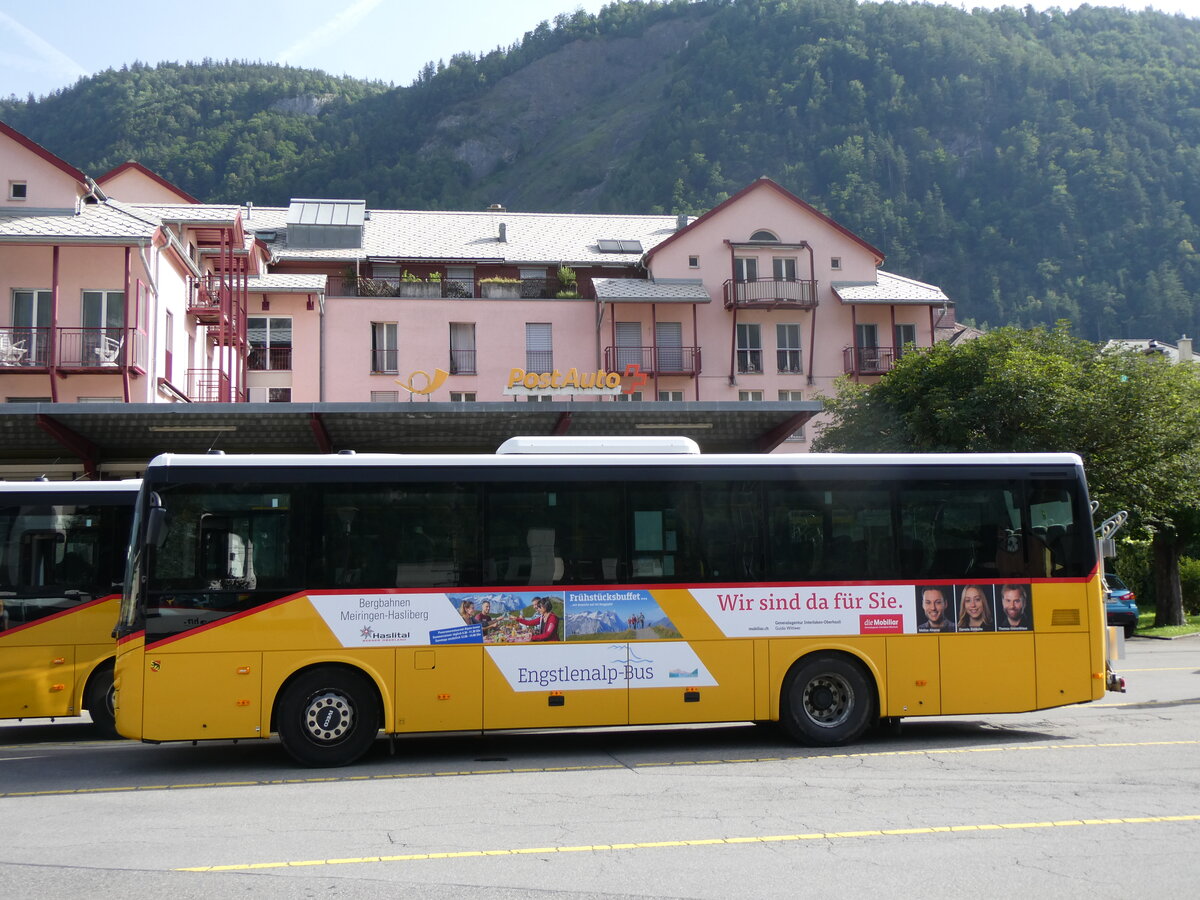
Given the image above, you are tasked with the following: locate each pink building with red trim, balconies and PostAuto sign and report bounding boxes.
[0,124,953,451]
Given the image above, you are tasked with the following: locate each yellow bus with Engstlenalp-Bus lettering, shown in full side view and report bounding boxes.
[116,438,1117,766]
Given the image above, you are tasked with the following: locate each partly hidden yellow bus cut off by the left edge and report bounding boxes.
[0,481,139,734]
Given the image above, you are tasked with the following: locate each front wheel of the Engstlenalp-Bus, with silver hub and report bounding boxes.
[275,666,379,767]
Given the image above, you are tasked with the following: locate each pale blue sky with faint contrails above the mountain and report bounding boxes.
[0,0,1200,98]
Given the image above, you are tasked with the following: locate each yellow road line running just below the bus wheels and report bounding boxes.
[0,740,1200,799]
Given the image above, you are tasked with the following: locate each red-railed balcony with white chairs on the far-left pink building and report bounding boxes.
[0,326,149,372]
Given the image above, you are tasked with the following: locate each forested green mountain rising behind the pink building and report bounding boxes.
[0,0,1200,338]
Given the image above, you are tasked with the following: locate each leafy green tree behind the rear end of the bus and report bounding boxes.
[814,323,1200,625]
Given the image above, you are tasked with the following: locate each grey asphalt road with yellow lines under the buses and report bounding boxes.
[0,638,1200,900]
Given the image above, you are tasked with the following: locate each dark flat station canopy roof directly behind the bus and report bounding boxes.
[0,400,822,479]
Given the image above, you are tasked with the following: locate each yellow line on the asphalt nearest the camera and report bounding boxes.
[174,815,1200,872]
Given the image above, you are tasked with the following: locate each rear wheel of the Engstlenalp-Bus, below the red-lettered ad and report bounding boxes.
[779,653,877,746]
